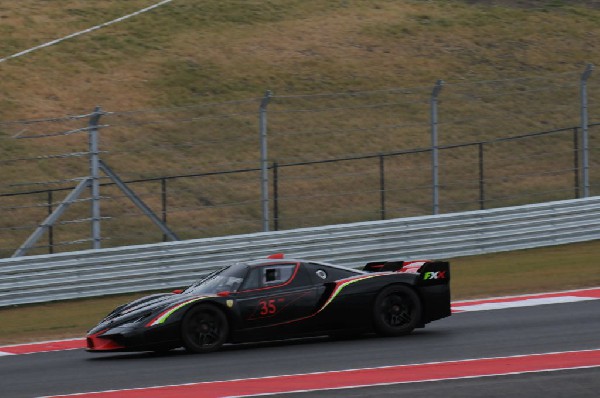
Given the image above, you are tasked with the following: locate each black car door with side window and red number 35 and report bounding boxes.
[236,263,318,332]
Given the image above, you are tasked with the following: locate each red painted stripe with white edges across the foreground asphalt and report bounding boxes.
[45,350,600,398]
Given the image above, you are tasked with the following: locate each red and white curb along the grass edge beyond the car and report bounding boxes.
[0,287,600,357]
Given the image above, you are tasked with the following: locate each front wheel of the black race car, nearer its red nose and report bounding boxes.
[181,304,229,354]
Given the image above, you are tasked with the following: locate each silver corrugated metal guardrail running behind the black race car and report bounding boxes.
[0,197,600,307]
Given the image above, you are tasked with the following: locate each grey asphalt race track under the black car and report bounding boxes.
[0,300,600,398]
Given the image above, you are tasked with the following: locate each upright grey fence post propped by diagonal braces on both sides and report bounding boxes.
[89,106,102,249]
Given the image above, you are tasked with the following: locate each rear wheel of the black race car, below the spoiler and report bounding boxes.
[373,285,423,336]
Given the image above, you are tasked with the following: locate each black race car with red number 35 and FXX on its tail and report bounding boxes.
[87,254,450,353]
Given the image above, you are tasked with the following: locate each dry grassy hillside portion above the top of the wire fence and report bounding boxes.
[0,0,600,116]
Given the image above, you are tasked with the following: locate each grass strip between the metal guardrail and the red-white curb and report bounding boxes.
[0,241,600,344]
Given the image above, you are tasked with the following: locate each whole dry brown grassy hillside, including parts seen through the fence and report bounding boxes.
[0,0,600,255]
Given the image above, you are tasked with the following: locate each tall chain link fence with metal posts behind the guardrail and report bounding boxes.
[0,71,600,257]
